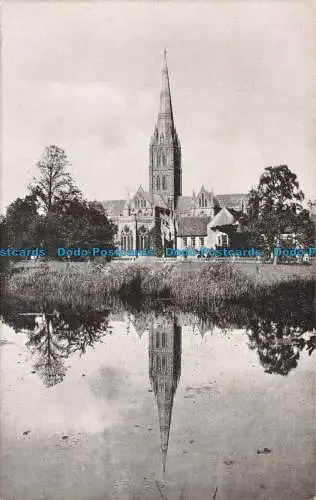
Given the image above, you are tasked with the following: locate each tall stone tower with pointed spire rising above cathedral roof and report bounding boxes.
[149,50,182,209]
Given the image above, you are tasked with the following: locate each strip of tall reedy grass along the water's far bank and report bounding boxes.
[5,261,316,310]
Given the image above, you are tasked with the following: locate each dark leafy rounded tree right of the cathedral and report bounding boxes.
[243,165,311,260]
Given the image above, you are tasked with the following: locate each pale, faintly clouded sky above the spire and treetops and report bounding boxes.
[1,0,316,209]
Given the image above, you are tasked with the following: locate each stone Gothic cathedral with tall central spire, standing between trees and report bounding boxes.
[101,51,247,256]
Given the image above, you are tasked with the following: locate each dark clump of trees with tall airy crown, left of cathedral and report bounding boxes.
[0,145,116,257]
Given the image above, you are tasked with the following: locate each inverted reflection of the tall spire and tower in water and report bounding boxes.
[148,315,182,472]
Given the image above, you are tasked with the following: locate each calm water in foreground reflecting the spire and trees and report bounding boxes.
[1,304,315,500]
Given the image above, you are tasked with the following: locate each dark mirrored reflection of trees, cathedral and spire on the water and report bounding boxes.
[2,298,316,473]
